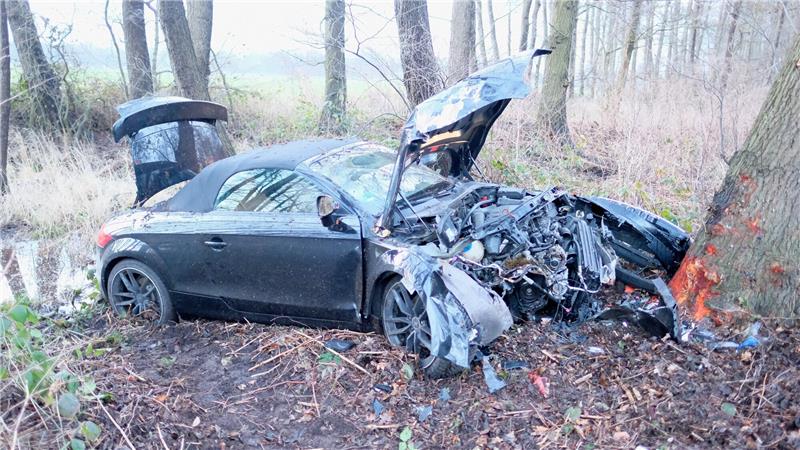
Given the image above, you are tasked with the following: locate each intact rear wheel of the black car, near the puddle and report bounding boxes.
[106,259,177,325]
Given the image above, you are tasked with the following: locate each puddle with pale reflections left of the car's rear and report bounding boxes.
[0,240,90,303]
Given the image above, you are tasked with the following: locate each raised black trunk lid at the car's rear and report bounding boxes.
[112,97,229,205]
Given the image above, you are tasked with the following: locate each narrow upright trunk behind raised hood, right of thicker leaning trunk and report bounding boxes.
[447,1,477,84]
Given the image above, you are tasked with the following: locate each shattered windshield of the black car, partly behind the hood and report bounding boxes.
[308,144,452,216]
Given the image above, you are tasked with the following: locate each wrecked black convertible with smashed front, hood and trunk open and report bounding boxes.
[97,50,690,377]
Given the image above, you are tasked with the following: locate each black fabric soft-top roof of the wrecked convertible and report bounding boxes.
[166,139,357,212]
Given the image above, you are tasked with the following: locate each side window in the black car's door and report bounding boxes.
[214,169,322,213]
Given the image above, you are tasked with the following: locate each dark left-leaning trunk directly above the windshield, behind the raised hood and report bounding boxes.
[394,0,444,108]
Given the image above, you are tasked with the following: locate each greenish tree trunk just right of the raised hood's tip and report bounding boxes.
[537,0,578,147]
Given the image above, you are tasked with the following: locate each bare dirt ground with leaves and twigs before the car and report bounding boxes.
[59,310,800,449]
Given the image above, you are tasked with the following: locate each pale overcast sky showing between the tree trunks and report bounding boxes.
[25,0,520,71]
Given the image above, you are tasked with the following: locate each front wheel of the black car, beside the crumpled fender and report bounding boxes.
[379,279,462,379]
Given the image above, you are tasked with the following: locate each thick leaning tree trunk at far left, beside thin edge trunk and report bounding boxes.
[6,0,63,131]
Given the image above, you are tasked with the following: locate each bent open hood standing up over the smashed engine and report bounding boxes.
[378,49,550,230]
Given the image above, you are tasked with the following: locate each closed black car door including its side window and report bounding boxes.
[203,169,363,323]
